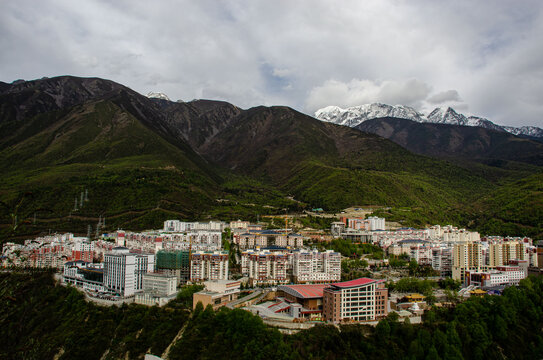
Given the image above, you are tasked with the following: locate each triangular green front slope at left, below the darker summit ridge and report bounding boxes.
[0,101,218,242]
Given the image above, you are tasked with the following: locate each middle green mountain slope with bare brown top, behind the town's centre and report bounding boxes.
[201,107,492,209]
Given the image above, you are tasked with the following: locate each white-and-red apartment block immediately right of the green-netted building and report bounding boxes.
[190,251,228,282]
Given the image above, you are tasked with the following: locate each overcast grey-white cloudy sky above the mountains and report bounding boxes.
[0,0,543,126]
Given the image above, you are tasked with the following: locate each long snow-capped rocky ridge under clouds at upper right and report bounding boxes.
[315,103,543,137]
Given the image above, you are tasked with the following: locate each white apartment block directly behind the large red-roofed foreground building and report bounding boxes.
[291,250,341,283]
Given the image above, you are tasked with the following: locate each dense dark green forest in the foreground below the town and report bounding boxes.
[0,272,543,359]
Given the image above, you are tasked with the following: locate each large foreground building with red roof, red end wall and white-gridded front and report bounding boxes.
[323,278,388,322]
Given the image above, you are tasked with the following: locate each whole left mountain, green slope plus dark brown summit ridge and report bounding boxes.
[0,77,224,240]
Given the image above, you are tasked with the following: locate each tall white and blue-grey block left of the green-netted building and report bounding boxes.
[104,247,155,297]
